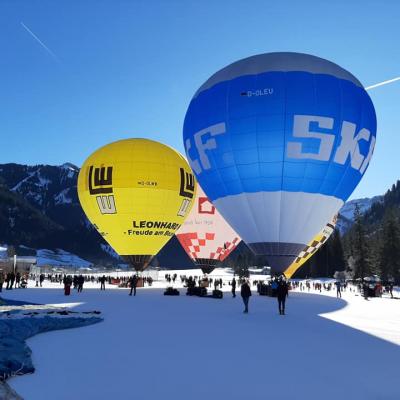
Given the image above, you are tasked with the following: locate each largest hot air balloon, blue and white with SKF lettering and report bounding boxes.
[183,53,376,272]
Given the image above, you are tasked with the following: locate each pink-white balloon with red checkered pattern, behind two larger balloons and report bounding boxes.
[176,185,241,274]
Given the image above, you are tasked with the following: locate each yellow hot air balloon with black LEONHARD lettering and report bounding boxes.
[78,139,196,271]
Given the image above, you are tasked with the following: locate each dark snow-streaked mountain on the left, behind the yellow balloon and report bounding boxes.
[0,163,193,268]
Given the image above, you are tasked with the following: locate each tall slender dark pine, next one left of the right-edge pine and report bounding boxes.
[352,205,371,279]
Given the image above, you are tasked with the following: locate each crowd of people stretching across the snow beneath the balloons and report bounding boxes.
[0,270,393,315]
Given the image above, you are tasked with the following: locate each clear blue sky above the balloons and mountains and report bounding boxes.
[0,0,400,198]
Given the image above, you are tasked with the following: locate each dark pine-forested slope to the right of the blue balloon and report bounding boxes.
[295,181,400,283]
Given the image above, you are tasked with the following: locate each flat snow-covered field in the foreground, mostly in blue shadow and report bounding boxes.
[2,271,400,400]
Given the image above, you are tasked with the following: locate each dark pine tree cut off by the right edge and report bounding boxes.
[379,209,400,282]
